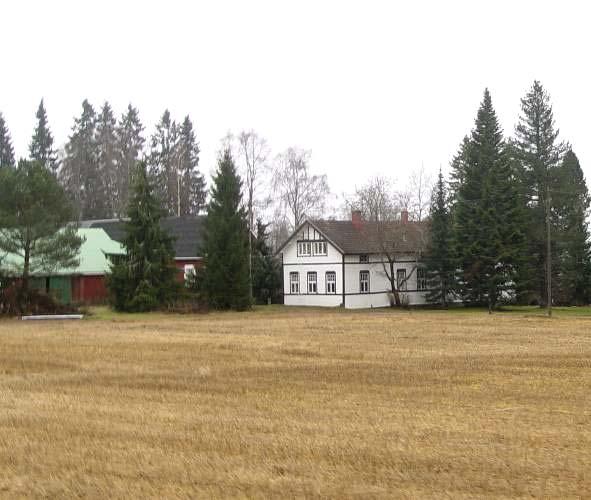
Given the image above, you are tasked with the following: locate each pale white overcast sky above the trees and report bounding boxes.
[0,0,591,201]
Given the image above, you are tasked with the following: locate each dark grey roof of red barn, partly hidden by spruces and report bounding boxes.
[80,215,205,259]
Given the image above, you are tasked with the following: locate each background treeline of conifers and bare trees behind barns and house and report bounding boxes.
[0,100,330,246]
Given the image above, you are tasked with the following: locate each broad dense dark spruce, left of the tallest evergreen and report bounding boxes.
[454,90,524,310]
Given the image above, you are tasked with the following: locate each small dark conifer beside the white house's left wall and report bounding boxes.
[252,219,281,304]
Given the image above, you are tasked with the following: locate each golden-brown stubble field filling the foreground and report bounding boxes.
[0,308,591,498]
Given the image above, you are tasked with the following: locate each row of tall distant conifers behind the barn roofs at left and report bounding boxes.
[0,100,206,219]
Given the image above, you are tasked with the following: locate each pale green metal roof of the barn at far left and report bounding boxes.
[0,228,125,276]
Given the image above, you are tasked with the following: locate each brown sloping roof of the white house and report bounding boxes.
[310,220,427,254]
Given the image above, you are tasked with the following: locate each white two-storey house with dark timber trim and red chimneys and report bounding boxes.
[277,211,427,308]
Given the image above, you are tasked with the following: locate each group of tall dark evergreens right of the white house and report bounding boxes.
[426,81,591,309]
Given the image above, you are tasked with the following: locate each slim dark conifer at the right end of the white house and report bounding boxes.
[424,169,454,307]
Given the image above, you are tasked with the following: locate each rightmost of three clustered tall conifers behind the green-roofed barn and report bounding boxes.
[114,104,145,217]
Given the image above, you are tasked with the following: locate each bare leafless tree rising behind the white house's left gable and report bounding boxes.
[272,148,330,229]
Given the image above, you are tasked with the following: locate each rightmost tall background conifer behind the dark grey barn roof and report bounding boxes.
[176,116,205,215]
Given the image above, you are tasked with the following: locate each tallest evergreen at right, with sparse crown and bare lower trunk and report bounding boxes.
[512,81,565,304]
